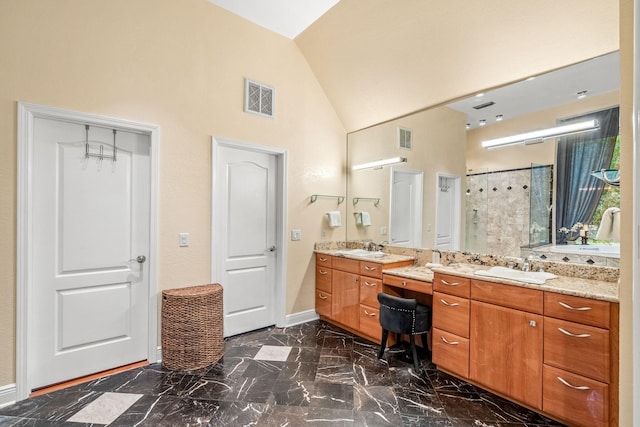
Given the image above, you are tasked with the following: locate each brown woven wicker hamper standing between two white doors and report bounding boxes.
[161,284,224,371]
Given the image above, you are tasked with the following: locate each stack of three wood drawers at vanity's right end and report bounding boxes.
[543,292,618,426]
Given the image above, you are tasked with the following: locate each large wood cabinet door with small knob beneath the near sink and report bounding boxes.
[469,301,543,409]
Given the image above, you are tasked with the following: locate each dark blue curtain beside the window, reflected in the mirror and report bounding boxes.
[556,107,620,243]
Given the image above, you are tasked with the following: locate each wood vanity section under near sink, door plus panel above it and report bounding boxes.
[469,280,543,410]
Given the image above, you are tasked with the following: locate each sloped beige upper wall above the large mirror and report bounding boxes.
[296,0,619,131]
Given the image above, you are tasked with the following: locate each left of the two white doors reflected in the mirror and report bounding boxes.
[389,168,424,247]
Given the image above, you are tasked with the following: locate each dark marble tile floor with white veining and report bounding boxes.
[0,321,561,427]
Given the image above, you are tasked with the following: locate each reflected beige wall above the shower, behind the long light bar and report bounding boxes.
[467,91,620,172]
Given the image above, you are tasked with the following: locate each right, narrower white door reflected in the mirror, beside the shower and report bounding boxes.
[436,174,460,250]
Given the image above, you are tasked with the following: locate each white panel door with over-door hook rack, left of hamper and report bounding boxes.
[27,117,150,389]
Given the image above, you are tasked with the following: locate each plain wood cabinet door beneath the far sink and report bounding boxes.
[331,270,360,329]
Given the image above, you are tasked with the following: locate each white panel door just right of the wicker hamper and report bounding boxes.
[213,146,279,336]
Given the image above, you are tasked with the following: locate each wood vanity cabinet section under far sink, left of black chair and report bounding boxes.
[316,254,413,343]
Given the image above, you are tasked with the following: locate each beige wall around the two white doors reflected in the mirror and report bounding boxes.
[347,107,466,248]
